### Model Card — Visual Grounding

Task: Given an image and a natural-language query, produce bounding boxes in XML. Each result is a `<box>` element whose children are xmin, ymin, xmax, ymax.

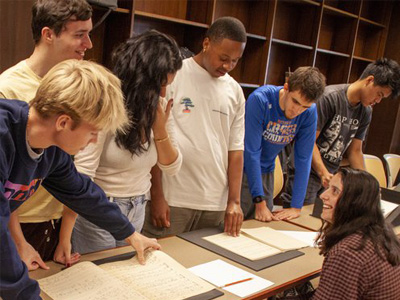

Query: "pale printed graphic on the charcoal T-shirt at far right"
<box><xmin>318</xmin><ymin>114</ymin><xmax>360</xmax><ymax>164</ymax></box>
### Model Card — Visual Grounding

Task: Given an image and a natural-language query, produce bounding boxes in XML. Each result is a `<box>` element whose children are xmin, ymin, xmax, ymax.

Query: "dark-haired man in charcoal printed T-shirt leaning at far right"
<box><xmin>282</xmin><ymin>58</ymin><xmax>400</xmax><ymax>210</ymax></box>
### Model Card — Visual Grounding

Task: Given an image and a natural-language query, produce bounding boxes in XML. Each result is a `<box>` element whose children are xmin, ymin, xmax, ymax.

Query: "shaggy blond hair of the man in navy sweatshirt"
<box><xmin>29</xmin><ymin>59</ymin><xmax>129</xmax><ymax>132</ymax></box>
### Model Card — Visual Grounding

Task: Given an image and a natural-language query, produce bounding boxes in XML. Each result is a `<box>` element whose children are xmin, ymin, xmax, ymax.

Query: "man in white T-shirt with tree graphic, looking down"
<box><xmin>143</xmin><ymin>17</ymin><xmax>246</xmax><ymax>237</ymax></box>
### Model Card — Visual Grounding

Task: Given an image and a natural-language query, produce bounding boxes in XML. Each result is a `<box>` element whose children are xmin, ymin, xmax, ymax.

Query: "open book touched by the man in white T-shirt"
<box><xmin>203</xmin><ymin>227</ymin><xmax>308</xmax><ymax>260</ymax></box>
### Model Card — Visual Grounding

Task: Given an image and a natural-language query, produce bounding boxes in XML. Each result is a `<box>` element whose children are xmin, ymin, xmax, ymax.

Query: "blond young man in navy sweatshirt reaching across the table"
<box><xmin>0</xmin><ymin>60</ymin><xmax>160</xmax><ymax>300</ymax></box>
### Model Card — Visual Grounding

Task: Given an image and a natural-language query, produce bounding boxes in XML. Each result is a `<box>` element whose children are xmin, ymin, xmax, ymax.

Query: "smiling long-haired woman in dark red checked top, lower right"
<box><xmin>312</xmin><ymin>168</ymin><xmax>400</xmax><ymax>300</ymax></box>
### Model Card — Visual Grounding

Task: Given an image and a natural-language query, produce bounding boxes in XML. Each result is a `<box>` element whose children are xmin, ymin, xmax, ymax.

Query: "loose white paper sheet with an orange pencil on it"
<box><xmin>188</xmin><ymin>259</ymin><xmax>274</xmax><ymax>297</ymax></box>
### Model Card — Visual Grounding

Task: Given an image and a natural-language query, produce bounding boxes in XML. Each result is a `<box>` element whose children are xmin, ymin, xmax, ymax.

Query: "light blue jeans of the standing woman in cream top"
<box><xmin>71</xmin><ymin>195</ymin><xmax>147</xmax><ymax>254</ymax></box>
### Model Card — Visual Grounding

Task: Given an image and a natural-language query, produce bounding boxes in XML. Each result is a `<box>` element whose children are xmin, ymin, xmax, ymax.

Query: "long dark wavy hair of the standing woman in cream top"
<box><xmin>112</xmin><ymin>30</ymin><xmax>182</xmax><ymax>155</ymax></box>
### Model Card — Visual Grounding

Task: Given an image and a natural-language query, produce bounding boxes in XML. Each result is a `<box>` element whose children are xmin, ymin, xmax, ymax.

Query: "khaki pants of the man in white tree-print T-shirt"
<box><xmin>142</xmin><ymin>201</ymin><xmax>225</xmax><ymax>238</ymax></box>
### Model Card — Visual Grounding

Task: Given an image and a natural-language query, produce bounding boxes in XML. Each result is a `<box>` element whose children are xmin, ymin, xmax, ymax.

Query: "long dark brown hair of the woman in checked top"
<box><xmin>317</xmin><ymin>168</ymin><xmax>400</xmax><ymax>266</ymax></box>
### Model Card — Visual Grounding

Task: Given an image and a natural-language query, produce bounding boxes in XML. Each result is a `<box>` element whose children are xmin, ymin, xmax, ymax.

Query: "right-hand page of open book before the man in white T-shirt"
<box><xmin>241</xmin><ymin>227</ymin><xmax>308</xmax><ymax>251</ymax></box>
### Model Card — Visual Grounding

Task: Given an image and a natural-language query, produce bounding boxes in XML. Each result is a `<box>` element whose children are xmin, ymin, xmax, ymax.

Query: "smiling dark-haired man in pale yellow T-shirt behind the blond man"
<box><xmin>0</xmin><ymin>0</ymin><xmax>92</xmax><ymax>270</ymax></box>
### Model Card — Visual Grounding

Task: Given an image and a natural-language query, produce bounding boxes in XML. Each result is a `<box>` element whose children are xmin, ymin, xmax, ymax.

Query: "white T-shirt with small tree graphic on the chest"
<box><xmin>163</xmin><ymin>58</ymin><xmax>245</xmax><ymax>211</ymax></box>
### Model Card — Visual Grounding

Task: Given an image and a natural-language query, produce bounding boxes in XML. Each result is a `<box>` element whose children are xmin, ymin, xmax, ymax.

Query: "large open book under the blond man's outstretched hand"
<box><xmin>39</xmin><ymin>251</ymin><xmax>214</xmax><ymax>300</ymax></box>
